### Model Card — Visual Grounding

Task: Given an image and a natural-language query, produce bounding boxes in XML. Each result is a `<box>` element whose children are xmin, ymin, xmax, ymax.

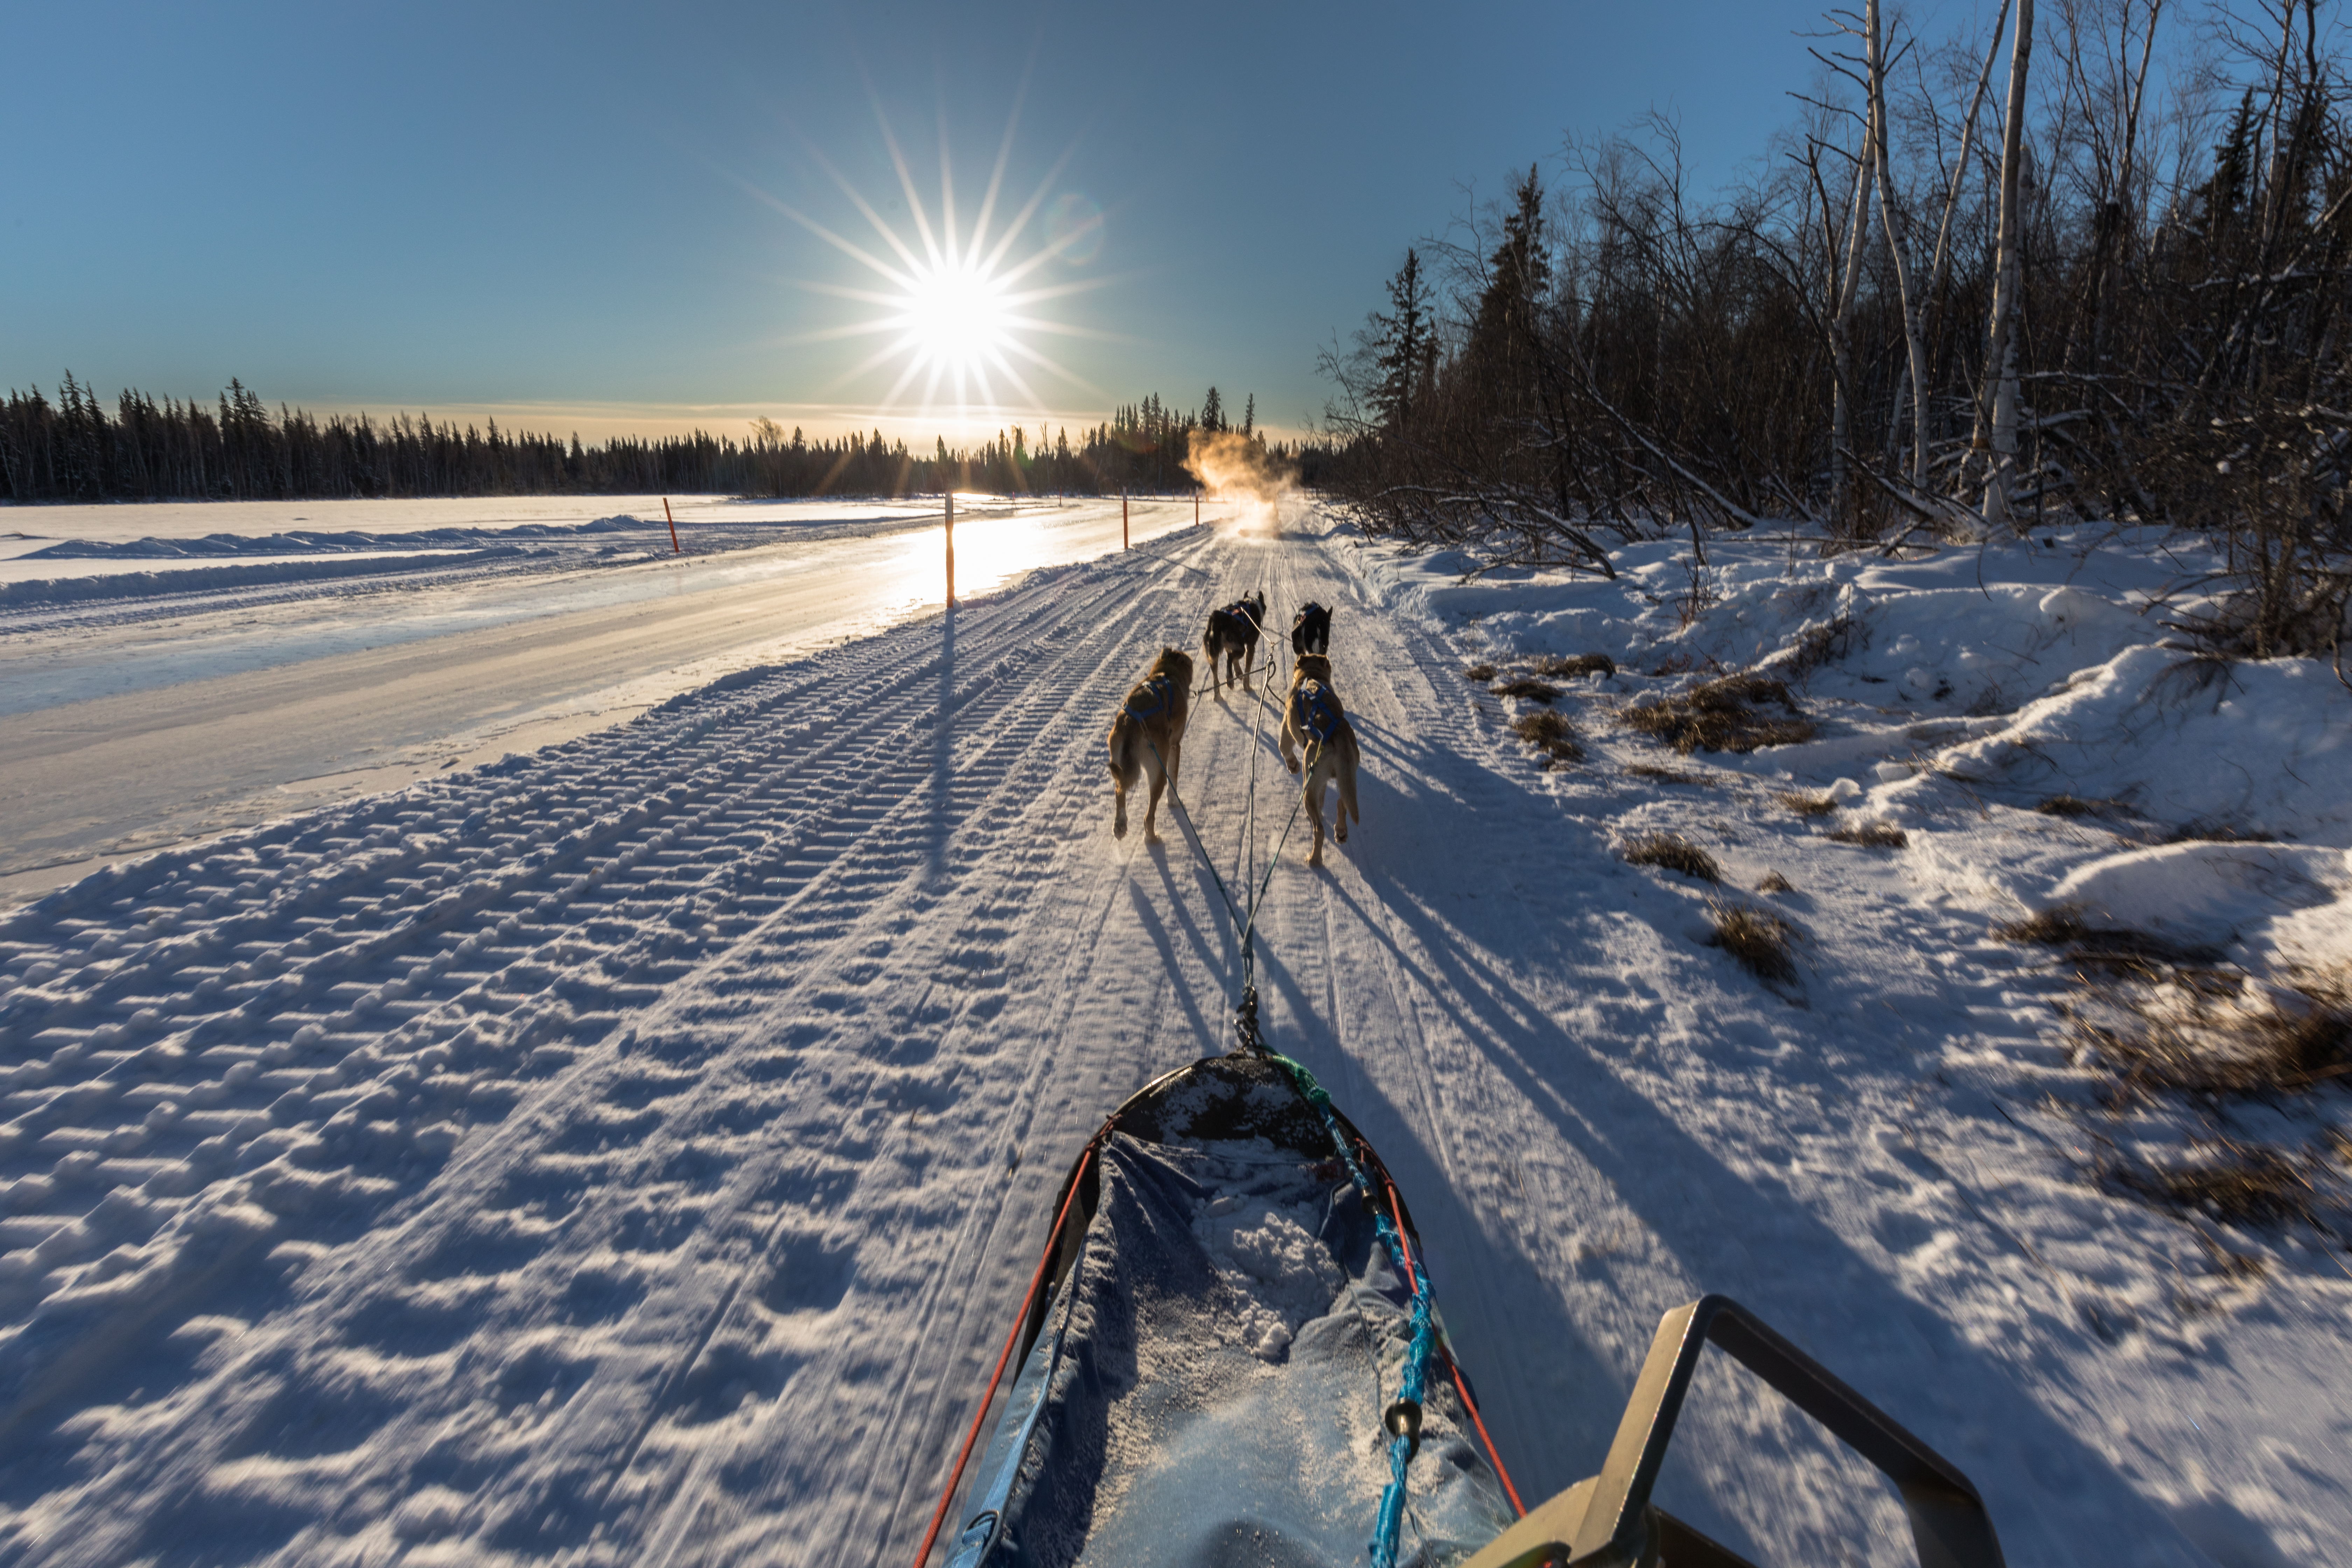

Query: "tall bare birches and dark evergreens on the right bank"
<box><xmin>1320</xmin><ymin>0</ymin><xmax>2352</xmax><ymax>656</ymax></box>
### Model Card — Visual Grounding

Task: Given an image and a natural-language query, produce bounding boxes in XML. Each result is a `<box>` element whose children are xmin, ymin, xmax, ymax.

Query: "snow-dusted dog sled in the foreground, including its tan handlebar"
<box><xmin>917</xmin><ymin>1053</ymin><xmax>2002</xmax><ymax>1568</ymax></box>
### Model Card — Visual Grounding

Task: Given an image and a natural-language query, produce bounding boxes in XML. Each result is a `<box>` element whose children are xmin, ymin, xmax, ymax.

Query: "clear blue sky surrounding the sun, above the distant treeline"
<box><xmin>0</xmin><ymin>0</ymin><xmax>1853</xmax><ymax>440</ymax></box>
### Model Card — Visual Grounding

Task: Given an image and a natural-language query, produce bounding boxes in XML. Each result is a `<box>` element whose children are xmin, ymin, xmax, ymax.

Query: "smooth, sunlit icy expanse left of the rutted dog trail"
<box><xmin>0</xmin><ymin>498</ymin><xmax>1221</xmax><ymax>903</ymax></box>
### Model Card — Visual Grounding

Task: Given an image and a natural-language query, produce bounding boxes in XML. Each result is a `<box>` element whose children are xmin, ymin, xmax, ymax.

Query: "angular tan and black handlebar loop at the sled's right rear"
<box><xmin>1463</xmin><ymin>1295</ymin><xmax>2002</xmax><ymax>1568</ymax></box>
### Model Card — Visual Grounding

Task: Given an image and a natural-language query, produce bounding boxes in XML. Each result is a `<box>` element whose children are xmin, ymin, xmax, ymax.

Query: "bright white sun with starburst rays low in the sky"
<box><xmin>752</xmin><ymin>104</ymin><xmax>1120</xmax><ymax>425</ymax></box>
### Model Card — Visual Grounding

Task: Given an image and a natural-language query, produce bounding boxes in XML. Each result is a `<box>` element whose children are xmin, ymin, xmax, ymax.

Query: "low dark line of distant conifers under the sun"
<box><xmin>0</xmin><ymin>374</ymin><xmax>1320</xmax><ymax>501</ymax></box>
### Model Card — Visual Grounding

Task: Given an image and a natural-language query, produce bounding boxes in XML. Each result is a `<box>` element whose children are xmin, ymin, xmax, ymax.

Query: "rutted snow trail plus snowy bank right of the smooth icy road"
<box><xmin>0</xmin><ymin>517</ymin><xmax>2352</xmax><ymax>1568</ymax></box>
